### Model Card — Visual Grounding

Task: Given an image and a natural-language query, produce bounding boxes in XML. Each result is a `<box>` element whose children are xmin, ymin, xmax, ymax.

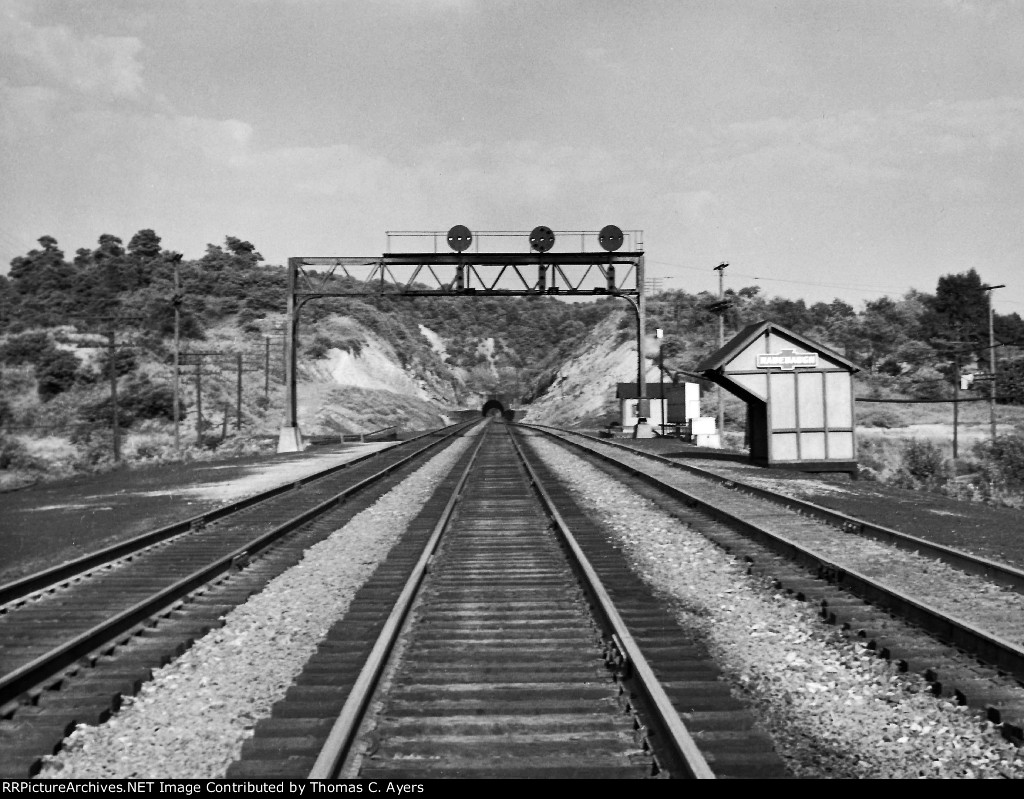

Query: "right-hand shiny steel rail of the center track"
<box><xmin>510</xmin><ymin>430</ymin><xmax>716</xmax><ymax>780</ymax></box>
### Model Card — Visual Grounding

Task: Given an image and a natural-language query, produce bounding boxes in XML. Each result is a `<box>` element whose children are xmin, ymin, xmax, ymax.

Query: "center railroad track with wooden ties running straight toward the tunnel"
<box><xmin>227</xmin><ymin>424</ymin><xmax>786</xmax><ymax>779</ymax></box>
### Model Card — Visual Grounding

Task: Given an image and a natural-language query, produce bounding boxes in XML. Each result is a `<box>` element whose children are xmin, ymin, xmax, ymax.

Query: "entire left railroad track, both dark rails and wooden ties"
<box><xmin>0</xmin><ymin>425</ymin><xmax>471</xmax><ymax>777</ymax></box>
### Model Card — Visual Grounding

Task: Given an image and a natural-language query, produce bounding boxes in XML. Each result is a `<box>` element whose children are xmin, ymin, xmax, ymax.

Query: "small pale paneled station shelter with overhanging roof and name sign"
<box><xmin>696</xmin><ymin>321</ymin><xmax>860</xmax><ymax>474</ymax></box>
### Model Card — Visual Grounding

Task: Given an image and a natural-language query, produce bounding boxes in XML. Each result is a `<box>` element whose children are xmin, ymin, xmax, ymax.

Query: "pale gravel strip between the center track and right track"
<box><xmin>530</xmin><ymin>437</ymin><xmax>1024</xmax><ymax>779</ymax></box>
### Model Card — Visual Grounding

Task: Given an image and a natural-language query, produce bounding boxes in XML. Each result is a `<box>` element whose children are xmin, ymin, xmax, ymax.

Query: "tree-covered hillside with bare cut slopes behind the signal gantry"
<box><xmin>0</xmin><ymin>229</ymin><xmax>1024</xmax><ymax>482</ymax></box>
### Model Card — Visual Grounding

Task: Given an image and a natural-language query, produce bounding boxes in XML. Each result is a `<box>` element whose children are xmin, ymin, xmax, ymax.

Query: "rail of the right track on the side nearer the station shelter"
<box><xmin>522</xmin><ymin>424</ymin><xmax>1024</xmax><ymax>593</ymax></box>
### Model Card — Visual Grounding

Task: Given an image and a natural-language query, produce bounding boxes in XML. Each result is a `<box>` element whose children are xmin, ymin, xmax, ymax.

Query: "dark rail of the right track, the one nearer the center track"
<box><xmin>527</xmin><ymin>426</ymin><xmax>1024</xmax><ymax>680</ymax></box>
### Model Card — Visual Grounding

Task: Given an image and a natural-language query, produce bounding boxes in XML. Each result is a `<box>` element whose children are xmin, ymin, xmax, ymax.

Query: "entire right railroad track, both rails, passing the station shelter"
<box><xmin>524</xmin><ymin>425</ymin><xmax>1024</xmax><ymax>741</ymax></box>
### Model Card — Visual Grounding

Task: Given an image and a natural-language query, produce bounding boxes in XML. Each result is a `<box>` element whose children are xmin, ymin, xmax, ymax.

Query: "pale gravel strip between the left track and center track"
<box><xmin>39</xmin><ymin>436</ymin><xmax>472</xmax><ymax>779</ymax></box>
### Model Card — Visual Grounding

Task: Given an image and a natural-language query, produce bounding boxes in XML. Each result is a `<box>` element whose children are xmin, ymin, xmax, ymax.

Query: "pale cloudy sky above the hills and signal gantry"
<box><xmin>0</xmin><ymin>0</ymin><xmax>1024</xmax><ymax>314</ymax></box>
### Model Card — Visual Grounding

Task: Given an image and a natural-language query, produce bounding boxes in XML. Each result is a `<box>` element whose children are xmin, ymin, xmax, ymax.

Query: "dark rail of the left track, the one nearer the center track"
<box><xmin>0</xmin><ymin>426</ymin><xmax>477</xmax><ymax>707</ymax></box>
